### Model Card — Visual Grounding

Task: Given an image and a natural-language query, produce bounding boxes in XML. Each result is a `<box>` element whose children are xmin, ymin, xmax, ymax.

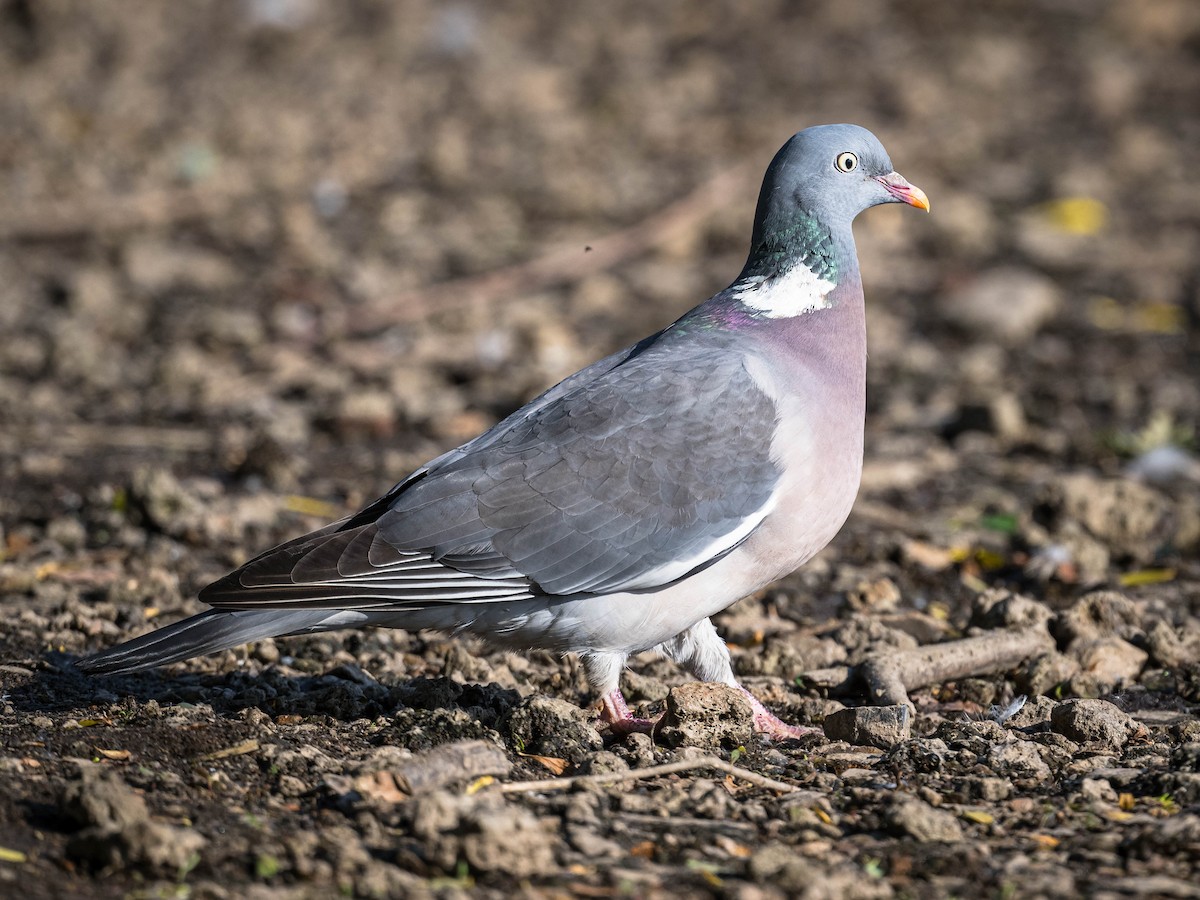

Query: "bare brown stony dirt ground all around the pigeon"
<box><xmin>0</xmin><ymin>0</ymin><xmax>1200</xmax><ymax>900</ymax></box>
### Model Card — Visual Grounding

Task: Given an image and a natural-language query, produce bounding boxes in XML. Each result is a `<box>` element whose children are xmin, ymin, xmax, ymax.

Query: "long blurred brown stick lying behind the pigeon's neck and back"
<box><xmin>350</xmin><ymin>164</ymin><xmax>750</xmax><ymax>336</ymax></box>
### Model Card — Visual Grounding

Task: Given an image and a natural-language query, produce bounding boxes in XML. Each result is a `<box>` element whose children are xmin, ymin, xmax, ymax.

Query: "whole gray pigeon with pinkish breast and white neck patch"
<box><xmin>77</xmin><ymin>125</ymin><xmax>929</xmax><ymax>739</ymax></box>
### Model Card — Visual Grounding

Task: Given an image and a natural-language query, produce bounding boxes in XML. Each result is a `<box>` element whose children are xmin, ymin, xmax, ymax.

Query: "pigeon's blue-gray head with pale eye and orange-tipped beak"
<box><xmin>750</xmin><ymin>125</ymin><xmax>929</xmax><ymax>267</ymax></box>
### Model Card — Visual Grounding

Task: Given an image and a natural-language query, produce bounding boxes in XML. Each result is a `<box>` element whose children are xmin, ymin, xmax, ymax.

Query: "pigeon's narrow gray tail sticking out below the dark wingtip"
<box><xmin>76</xmin><ymin>610</ymin><xmax>347</xmax><ymax>674</ymax></box>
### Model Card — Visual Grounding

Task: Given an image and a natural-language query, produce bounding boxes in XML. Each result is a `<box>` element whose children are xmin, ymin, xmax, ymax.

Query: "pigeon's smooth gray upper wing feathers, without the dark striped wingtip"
<box><xmin>378</xmin><ymin>352</ymin><xmax>779</xmax><ymax>594</ymax></box>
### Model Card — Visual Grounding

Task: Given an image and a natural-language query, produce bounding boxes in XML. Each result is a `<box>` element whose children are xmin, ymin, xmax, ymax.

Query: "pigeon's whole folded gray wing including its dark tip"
<box><xmin>200</xmin><ymin>344</ymin><xmax>779</xmax><ymax>608</ymax></box>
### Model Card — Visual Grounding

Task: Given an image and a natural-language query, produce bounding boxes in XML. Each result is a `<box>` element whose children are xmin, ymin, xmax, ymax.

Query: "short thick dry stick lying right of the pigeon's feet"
<box><xmin>800</xmin><ymin>625</ymin><xmax>1054</xmax><ymax>706</ymax></box>
